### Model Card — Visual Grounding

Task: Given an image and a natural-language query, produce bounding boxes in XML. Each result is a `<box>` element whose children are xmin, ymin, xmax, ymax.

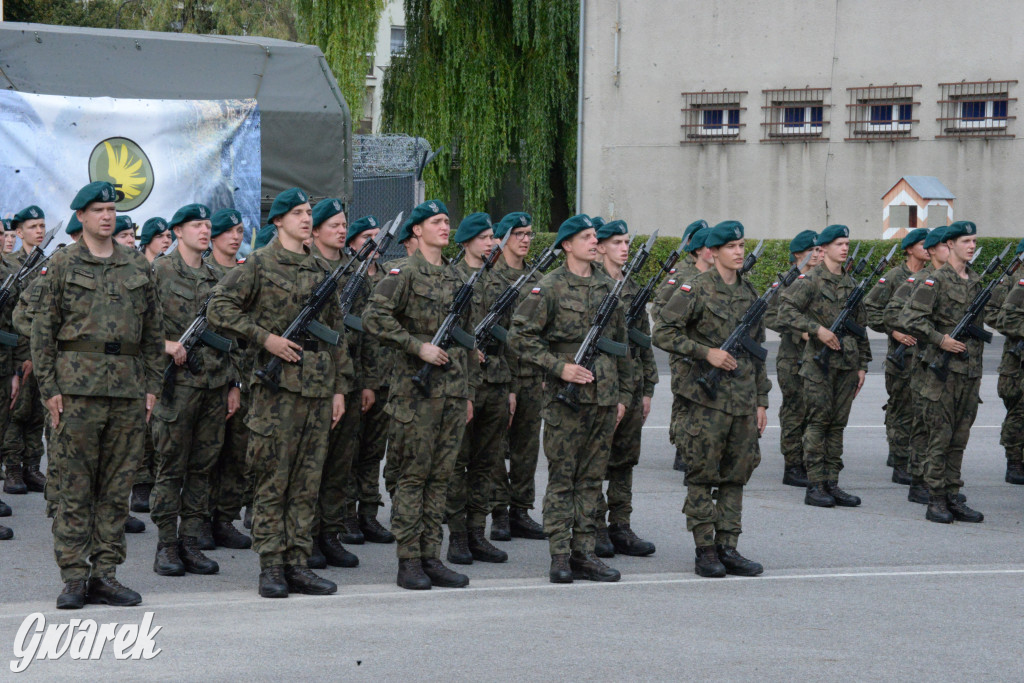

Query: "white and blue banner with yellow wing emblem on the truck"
<box><xmin>0</xmin><ymin>90</ymin><xmax>260</xmax><ymax>255</ymax></box>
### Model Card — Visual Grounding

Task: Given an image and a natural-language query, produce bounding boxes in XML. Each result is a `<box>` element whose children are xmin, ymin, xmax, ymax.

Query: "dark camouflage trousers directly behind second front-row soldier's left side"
<box><xmin>210</xmin><ymin>391</ymin><xmax>253</xmax><ymax>522</ymax></box>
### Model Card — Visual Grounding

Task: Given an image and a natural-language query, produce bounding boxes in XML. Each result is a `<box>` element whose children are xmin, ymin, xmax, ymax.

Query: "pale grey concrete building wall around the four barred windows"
<box><xmin>581</xmin><ymin>0</ymin><xmax>1024</xmax><ymax>238</ymax></box>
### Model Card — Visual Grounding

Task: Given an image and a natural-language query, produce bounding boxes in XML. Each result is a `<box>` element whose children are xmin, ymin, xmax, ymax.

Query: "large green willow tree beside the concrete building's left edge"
<box><xmin>383</xmin><ymin>0</ymin><xmax>579</xmax><ymax>225</ymax></box>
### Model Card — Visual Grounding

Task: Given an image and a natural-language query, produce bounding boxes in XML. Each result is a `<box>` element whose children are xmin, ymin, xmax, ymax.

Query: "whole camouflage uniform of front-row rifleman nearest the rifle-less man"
<box><xmin>207</xmin><ymin>241</ymin><xmax>357</xmax><ymax>569</ymax></box>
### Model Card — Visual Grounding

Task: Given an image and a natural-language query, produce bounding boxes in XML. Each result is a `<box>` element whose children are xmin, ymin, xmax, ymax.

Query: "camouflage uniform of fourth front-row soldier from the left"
<box><xmin>508</xmin><ymin>265</ymin><xmax>634</xmax><ymax>555</ymax></box>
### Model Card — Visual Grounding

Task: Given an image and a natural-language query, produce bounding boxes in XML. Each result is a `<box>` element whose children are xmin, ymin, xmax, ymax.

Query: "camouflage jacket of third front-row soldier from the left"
<box><xmin>362</xmin><ymin>252</ymin><xmax>480</xmax><ymax>400</ymax></box>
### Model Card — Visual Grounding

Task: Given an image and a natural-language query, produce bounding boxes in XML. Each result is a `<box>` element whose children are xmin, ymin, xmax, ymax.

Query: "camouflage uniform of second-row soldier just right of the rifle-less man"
<box><xmin>151</xmin><ymin>251</ymin><xmax>238</xmax><ymax>544</ymax></box>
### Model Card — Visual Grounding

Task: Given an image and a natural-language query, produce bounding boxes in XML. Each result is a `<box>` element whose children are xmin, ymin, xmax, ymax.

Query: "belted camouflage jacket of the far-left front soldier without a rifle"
<box><xmin>29</xmin><ymin>240</ymin><xmax>167</xmax><ymax>400</ymax></box>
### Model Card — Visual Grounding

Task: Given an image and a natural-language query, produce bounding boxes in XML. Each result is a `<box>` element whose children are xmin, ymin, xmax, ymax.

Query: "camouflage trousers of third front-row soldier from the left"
<box><xmin>388</xmin><ymin>396</ymin><xmax>467</xmax><ymax>560</ymax></box>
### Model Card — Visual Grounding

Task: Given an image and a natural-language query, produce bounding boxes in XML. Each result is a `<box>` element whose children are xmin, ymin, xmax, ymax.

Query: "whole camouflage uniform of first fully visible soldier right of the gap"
<box><xmin>778</xmin><ymin>263</ymin><xmax>871</xmax><ymax>485</ymax></box>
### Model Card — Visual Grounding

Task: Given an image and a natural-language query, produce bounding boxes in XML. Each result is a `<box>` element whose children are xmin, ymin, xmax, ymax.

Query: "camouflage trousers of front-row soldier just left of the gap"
<box><xmin>677</xmin><ymin>403</ymin><xmax>761</xmax><ymax>548</ymax></box>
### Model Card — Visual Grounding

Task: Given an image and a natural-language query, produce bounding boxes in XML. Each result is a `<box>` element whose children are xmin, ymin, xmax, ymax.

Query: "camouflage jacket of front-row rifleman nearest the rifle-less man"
<box><xmin>207</xmin><ymin>240</ymin><xmax>353</xmax><ymax>398</ymax></box>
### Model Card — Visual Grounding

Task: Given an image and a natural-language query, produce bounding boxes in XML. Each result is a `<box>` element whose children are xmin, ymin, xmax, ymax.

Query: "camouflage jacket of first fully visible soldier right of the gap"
<box><xmin>777</xmin><ymin>263</ymin><xmax>871</xmax><ymax>382</ymax></box>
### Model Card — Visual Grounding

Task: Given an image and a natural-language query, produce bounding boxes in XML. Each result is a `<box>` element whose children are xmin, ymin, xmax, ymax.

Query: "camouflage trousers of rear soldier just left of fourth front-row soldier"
<box><xmin>490</xmin><ymin>375</ymin><xmax>544</xmax><ymax>510</ymax></box>
